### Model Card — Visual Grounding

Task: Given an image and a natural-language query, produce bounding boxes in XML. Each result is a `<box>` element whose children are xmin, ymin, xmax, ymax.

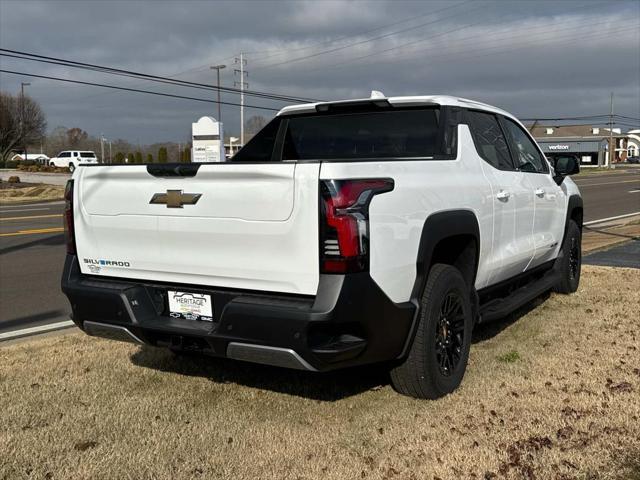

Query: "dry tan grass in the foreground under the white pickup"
<box><xmin>0</xmin><ymin>267</ymin><xmax>640</xmax><ymax>480</ymax></box>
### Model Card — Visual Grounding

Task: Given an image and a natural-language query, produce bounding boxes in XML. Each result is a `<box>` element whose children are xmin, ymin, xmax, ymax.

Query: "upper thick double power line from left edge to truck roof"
<box><xmin>0</xmin><ymin>48</ymin><xmax>318</xmax><ymax>103</ymax></box>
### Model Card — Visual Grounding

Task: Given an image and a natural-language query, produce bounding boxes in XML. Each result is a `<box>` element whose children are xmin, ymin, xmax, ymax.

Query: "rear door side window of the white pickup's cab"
<box><xmin>465</xmin><ymin>110</ymin><xmax>514</xmax><ymax>170</ymax></box>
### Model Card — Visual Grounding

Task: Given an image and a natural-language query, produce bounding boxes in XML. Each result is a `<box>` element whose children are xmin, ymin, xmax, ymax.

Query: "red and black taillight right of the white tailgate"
<box><xmin>320</xmin><ymin>178</ymin><xmax>393</xmax><ymax>273</ymax></box>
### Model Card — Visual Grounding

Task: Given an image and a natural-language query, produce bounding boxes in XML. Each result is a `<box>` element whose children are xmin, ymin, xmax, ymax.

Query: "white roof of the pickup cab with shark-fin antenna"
<box><xmin>278</xmin><ymin>92</ymin><xmax>515</xmax><ymax>118</ymax></box>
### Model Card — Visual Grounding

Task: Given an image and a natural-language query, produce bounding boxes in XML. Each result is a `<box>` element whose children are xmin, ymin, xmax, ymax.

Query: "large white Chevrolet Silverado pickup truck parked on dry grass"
<box><xmin>62</xmin><ymin>96</ymin><xmax>583</xmax><ymax>398</ymax></box>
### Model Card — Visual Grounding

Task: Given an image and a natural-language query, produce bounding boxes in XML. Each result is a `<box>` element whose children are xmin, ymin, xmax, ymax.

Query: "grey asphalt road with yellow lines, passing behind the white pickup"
<box><xmin>0</xmin><ymin>169</ymin><xmax>640</xmax><ymax>333</ymax></box>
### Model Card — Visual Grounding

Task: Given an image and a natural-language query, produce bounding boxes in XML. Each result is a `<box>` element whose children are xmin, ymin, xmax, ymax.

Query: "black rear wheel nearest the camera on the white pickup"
<box><xmin>391</xmin><ymin>263</ymin><xmax>473</xmax><ymax>399</ymax></box>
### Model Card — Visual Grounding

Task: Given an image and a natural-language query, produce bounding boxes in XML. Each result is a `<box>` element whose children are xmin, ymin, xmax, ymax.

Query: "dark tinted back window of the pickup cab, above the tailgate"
<box><xmin>282</xmin><ymin>108</ymin><xmax>448</xmax><ymax>160</ymax></box>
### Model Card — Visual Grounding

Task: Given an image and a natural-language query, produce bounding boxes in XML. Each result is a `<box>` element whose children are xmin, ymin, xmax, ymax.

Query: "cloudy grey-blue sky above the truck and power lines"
<box><xmin>0</xmin><ymin>0</ymin><xmax>640</xmax><ymax>143</ymax></box>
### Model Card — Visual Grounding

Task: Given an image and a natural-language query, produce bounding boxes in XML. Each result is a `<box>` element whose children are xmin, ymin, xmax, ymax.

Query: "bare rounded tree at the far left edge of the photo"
<box><xmin>0</xmin><ymin>92</ymin><xmax>47</xmax><ymax>160</ymax></box>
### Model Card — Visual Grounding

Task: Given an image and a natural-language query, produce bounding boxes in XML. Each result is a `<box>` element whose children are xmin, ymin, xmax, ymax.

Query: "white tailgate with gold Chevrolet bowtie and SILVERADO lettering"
<box><xmin>74</xmin><ymin>163</ymin><xmax>320</xmax><ymax>295</ymax></box>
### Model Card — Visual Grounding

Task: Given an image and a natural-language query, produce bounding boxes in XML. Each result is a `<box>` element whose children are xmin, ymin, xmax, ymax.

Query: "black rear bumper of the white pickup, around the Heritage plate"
<box><xmin>62</xmin><ymin>255</ymin><xmax>416</xmax><ymax>371</ymax></box>
